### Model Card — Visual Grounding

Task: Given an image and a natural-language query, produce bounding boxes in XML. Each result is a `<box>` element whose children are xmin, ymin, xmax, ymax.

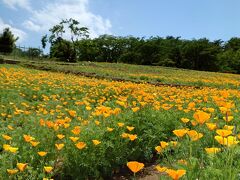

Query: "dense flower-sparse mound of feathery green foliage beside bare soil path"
<box><xmin>63</xmin><ymin>107</ymin><xmax>179</xmax><ymax>179</ymax></box>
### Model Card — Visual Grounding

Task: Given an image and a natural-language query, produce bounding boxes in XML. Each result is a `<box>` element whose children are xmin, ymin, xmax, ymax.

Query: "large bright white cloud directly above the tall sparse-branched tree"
<box><xmin>23</xmin><ymin>0</ymin><xmax>111</xmax><ymax>37</ymax></box>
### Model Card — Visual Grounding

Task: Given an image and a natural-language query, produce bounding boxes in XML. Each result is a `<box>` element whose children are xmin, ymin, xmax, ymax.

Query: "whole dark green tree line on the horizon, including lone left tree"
<box><xmin>0</xmin><ymin>18</ymin><xmax>240</xmax><ymax>73</ymax></box>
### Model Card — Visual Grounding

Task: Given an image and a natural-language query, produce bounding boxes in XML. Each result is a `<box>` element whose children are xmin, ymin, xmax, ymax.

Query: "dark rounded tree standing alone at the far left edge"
<box><xmin>0</xmin><ymin>28</ymin><xmax>18</xmax><ymax>53</ymax></box>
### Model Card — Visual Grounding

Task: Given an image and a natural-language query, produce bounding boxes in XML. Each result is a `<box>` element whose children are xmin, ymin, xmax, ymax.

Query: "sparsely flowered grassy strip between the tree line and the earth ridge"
<box><xmin>1</xmin><ymin>54</ymin><xmax>240</xmax><ymax>88</ymax></box>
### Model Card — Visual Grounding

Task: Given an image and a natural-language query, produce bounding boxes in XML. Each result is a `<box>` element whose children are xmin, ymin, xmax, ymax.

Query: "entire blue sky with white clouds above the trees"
<box><xmin>0</xmin><ymin>0</ymin><xmax>240</xmax><ymax>47</ymax></box>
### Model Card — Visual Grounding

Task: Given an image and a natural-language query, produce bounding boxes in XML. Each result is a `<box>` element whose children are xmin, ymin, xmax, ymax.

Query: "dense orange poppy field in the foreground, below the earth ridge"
<box><xmin>0</xmin><ymin>65</ymin><xmax>240</xmax><ymax>180</ymax></box>
